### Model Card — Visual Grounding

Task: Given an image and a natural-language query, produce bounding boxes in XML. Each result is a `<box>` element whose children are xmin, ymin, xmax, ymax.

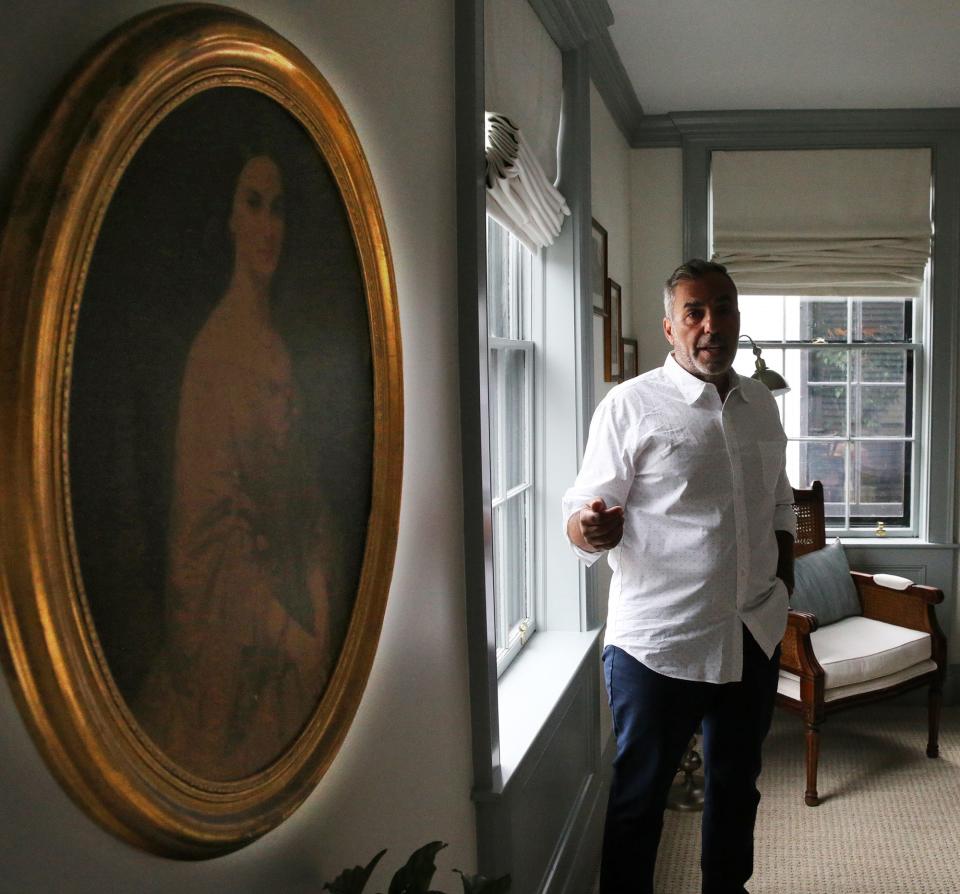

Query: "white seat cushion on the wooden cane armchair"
<box><xmin>779</xmin><ymin>616</ymin><xmax>936</xmax><ymax>701</ymax></box>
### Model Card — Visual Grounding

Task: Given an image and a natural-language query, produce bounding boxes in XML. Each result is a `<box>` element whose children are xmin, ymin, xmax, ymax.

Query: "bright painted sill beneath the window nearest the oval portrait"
<box><xmin>497</xmin><ymin>630</ymin><xmax>600</xmax><ymax>787</ymax></box>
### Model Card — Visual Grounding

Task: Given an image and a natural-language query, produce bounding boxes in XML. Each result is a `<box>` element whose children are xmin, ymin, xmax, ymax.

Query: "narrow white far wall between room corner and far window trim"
<box><xmin>630</xmin><ymin>149</ymin><xmax>685</xmax><ymax>372</ymax></box>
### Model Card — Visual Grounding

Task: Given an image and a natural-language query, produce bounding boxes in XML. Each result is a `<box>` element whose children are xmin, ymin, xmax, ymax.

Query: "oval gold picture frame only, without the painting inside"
<box><xmin>0</xmin><ymin>4</ymin><xmax>403</xmax><ymax>858</ymax></box>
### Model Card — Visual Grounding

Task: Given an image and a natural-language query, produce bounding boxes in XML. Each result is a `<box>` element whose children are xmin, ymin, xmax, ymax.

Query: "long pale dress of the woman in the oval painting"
<box><xmin>137</xmin><ymin>300</ymin><xmax>333</xmax><ymax>779</ymax></box>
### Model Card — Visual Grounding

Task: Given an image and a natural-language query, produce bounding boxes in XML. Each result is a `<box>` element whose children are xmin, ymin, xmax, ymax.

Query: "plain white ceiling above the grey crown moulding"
<box><xmin>608</xmin><ymin>0</ymin><xmax>960</xmax><ymax>115</ymax></box>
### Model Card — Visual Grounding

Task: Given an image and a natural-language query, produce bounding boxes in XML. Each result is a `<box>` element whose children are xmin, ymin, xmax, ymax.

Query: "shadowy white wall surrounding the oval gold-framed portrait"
<box><xmin>0</xmin><ymin>0</ymin><xmax>476</xmax><ymax>894</ymax></box>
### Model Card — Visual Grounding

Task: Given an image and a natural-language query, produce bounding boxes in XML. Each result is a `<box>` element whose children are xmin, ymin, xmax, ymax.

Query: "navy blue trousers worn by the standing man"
<box><xmin>600</xmin><ymin>627</ymin><xmax>780</xmax><ymax>894</ymax></box>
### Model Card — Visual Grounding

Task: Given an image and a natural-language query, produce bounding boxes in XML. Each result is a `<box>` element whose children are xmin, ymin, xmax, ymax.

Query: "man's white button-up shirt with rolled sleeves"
<box><xmin>563</xmin><ymin>355</ymin><xmax>796</xmax><ymax>683</ymax></box>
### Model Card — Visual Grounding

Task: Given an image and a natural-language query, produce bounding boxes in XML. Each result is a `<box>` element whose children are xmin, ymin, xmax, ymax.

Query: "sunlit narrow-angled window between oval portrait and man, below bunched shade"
<box><xmin>487</xmin><ymin>217</ymin><xmax>542</xmax><ymax>671</ymax></box>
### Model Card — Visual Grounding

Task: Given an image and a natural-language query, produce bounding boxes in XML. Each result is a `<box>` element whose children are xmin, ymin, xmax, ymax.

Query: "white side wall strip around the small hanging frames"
<box><xmin>590</xmin><ymin>83</ymin><xmax>635</xmax><ymax>403</ymax></box>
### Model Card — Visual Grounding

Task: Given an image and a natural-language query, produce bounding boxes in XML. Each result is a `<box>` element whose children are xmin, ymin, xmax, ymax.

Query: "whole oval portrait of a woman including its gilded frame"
<box><xmin>0</xmin><ymin>4</ymin><xmax>403</xmax><ymax>859</ymax></box>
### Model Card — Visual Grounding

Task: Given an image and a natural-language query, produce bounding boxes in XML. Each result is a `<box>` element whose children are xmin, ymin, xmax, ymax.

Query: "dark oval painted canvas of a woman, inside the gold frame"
<box><xmin>72</xmin><ymin>91</ymin><xmax>372</xmax><ymax>780</ymax></box>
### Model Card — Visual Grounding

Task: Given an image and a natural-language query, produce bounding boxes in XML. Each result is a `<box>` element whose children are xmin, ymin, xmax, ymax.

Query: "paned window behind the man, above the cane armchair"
<box><xmin>735</xmin><ymin>295</ymin><xmax>922</xmax><ymax>536</ymax></box>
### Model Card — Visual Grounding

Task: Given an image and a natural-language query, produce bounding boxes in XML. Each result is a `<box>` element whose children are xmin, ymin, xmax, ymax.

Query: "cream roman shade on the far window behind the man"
<box><xmin>710</xmin><ymin>149</ymin><xmax>932</xmax><ymax>297</ymax></box>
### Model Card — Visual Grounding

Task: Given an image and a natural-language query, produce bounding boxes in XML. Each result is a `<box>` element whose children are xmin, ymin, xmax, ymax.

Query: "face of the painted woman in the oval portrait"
<box><xmin>229</xmin><ymin>155</ymin><xmax>284</xmax><ymax>279</ymax></box>
